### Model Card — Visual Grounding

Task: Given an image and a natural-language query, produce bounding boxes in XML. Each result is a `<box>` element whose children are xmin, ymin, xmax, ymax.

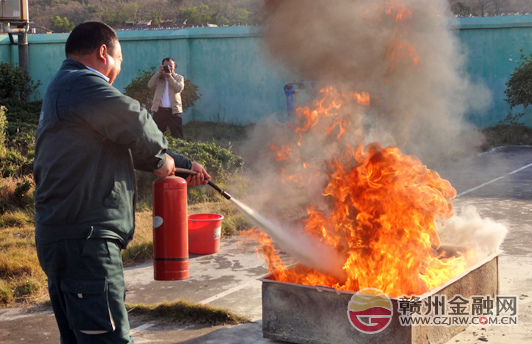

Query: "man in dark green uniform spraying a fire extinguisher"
<box><xmin>34</xmin><ymin>22</ymin><xmax>209</xmax><ymax>344</ymax></box>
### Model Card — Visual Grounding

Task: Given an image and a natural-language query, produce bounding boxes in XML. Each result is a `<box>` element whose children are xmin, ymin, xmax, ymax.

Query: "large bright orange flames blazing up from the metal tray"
<box><xmin>241</xmin><ymin>87</ymin><xmax>466</xmax><ymax>297</ymax></box>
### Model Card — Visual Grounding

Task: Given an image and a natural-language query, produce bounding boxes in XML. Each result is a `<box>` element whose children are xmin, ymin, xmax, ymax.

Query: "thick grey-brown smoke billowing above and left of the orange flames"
<box><xmin>243</xmin><ymin>0</ymin><xmax>490</xmax><ymax>216</ymax></box>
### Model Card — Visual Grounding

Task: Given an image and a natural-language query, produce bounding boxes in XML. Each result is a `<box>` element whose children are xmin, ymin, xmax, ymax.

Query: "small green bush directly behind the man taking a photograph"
<box><xmin>124</xmin><ymin>67</ymin><xmax>201</xmax><ymax>112</ymax></box>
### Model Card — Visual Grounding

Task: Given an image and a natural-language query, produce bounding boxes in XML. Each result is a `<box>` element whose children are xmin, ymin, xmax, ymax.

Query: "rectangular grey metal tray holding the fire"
<box><xmin>260</xmin><ymin>252</ymin><xmax>500</xmax><ymax>344</ymax></box>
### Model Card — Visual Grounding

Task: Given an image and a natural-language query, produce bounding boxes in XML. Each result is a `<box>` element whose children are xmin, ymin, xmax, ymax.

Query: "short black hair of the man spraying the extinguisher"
<box><xmin>65</xmin><ymin>22</ymin><xmax>118</xmax><ymax>58</ymax></box>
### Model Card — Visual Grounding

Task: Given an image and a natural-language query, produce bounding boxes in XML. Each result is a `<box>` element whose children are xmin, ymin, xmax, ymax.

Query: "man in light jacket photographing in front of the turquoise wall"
<box><xmin>148</xmin><ymin>57</ymin><xmax>185</xmax><ymax>139</ymax></box>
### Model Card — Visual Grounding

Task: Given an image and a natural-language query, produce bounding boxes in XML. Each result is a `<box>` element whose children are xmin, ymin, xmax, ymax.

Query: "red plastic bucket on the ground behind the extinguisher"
<box><xmin>188</xmin><ymin>214</ymin><xmax>224</xmax><ymax>254</ymax></box>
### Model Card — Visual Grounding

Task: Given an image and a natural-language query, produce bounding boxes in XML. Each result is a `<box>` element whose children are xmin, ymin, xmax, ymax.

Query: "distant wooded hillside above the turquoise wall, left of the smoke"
<box><xmin>29</xmin><ymin>0</ymin><xmax>262</xmax><ymax>32</ymax></box>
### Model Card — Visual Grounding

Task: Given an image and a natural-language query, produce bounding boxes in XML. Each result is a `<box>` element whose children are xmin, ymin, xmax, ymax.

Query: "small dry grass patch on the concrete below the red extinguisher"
<box><xmin>126</xmin><ymin>300</ymin><xmax>251</xmax><ymax>326</ymax></box>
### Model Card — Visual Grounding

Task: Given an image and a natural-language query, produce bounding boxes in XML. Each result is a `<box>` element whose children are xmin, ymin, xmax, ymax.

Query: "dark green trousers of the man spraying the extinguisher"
<box><xmin>36</xmin><ymin>238</ymin><xmax>133</xmax><ymax>344</ymax></box>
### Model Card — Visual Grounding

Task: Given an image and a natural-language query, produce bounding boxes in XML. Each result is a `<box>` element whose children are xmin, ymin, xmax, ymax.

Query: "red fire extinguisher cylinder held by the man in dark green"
<box><xmin>153</xmin><ymin>176</ymin><xmax>188</xmax><ymax>281</ymax></box>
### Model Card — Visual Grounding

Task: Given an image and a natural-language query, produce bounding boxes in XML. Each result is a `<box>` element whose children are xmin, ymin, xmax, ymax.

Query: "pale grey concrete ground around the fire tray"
<box><xmin>0</xmin><ymin>147</ymin><xmax>532</xmax><ymax>344</ymax></box>
